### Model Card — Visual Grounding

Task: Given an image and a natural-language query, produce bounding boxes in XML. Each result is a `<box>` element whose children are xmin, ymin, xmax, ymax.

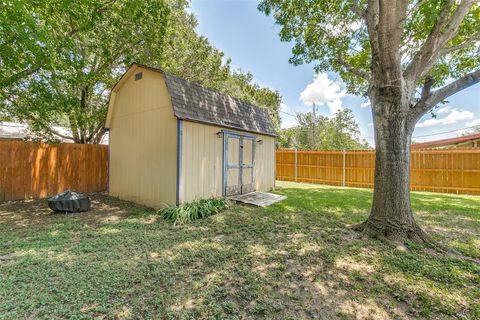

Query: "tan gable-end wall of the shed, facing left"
<box><xmin>109</xmin><ymin>68</ymin><xmax>177</xmax><ymax>207</ymax></box>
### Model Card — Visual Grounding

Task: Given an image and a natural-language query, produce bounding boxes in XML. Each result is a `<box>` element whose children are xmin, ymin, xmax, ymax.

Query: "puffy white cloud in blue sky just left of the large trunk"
<box><xmin>300</xmin><ymin>73</ymin><xmax>347</xmax><ymax>114</ymax></box>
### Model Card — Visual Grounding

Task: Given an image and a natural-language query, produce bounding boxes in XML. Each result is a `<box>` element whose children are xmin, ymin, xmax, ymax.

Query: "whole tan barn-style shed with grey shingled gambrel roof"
<box><xmin>105</xmin><ymin>63</ymin><xmax>276</xmax><ymax>207</ymax></box>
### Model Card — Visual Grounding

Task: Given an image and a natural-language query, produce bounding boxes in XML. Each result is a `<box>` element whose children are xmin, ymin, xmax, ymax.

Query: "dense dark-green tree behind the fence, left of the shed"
<box><xmin>0</xmin><ymin>0</ymin><xmax>170</xmax><ymax>143</ymax></box>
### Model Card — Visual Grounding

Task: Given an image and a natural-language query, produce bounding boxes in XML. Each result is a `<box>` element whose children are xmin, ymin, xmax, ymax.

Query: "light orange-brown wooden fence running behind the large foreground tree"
<box><xmin>276</xmin><ymin>148</ymin><xmax>480</xmax><ymax>194</ymax></box>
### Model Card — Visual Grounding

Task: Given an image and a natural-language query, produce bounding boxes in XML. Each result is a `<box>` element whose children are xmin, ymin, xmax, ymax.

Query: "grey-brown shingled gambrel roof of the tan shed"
<box><xmin>106</xmin><ymin>63</ymin><xmax>276</xmax><ymax>136</ymax></box>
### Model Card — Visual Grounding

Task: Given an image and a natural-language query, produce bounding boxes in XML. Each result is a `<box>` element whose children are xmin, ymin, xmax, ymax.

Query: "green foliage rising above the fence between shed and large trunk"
<box><xmin>278</xmin><ymin>109</ymin><xmax>369</xmax><ymax>150</ymax></box>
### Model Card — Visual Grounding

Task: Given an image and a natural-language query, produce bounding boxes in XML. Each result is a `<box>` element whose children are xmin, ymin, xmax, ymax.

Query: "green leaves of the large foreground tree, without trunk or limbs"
<box><xmin>258</xmin><ymin>0</ymin><xmax>480</xmax><ymax>95</ymax></box>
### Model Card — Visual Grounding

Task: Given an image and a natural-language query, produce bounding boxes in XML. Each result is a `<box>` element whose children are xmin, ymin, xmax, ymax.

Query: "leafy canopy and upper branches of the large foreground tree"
<box><xmin>259</xmin><ymin>0</ymin><xmax>480</xmax><ymax>100</ymax></box>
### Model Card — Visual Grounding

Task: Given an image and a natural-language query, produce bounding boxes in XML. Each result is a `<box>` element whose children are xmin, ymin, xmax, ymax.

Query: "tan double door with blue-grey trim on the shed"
<box><xmin>224</xmin><ymin>133</ymin><xmax>255</xmax><ymax>196</ymax></box>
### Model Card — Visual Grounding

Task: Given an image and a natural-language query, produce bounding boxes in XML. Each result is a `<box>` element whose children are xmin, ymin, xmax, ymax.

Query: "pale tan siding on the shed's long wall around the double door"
<box><xmin>180</xmin><ymin>121</ymin><xmax>275</xmax><ymax>202</ymax></box>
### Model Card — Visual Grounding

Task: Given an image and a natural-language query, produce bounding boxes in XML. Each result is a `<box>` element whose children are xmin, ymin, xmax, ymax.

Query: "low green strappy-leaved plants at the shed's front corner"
<box><xmin>159</xmin><ymin>198</ymin><xmax>229</xmax><ymax>225</ymax></box>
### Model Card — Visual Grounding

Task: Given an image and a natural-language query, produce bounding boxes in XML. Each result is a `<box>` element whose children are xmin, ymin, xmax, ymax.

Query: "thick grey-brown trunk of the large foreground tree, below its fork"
<box><xmin>355</xmin><ymin>97</ymin><xmax>428</xmax><ymax>243</ymax></box>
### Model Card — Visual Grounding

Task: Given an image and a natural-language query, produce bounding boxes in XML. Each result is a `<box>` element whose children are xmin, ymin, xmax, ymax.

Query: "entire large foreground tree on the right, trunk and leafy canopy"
<box><xmin>259</xmin><ymin>0</ymin><xmax>480</xmax><ymax>243</ymax></box>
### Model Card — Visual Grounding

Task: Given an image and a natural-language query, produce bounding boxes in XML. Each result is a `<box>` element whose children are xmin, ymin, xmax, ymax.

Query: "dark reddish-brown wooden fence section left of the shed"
<box><xmin>0</xmin><ymin>140</ymin><xmax>108</xmax><ymax>201</ymax></box>
